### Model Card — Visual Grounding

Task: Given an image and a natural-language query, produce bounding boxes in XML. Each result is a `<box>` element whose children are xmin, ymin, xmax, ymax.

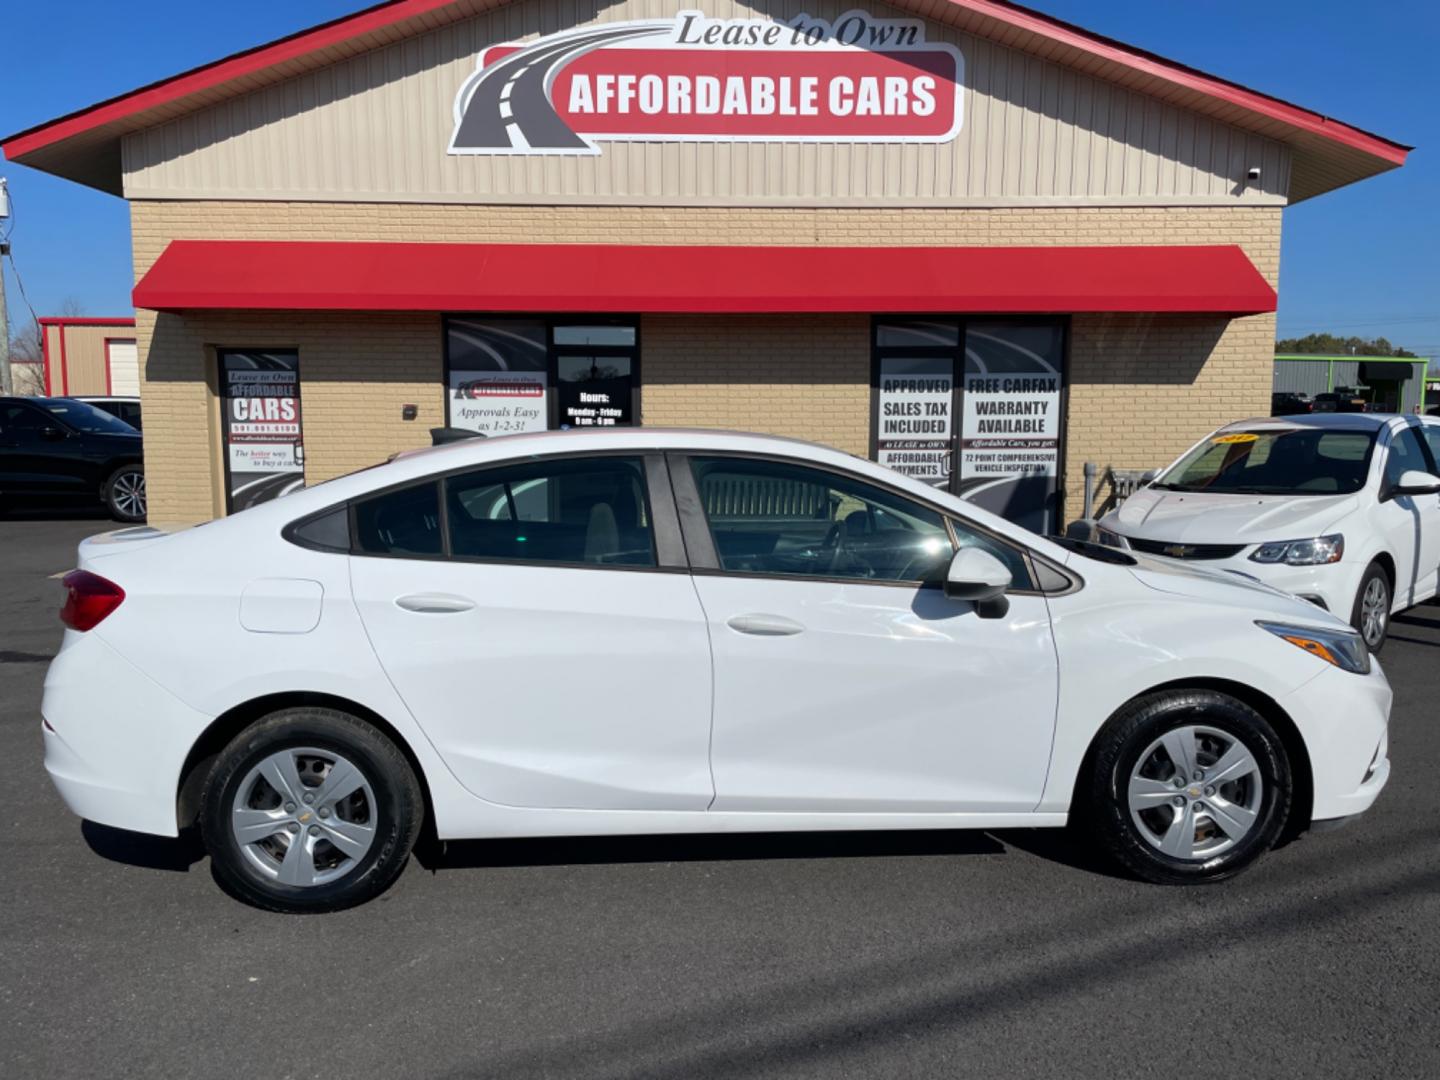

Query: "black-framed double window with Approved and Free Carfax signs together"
<box><xmin>874</xmin><ymin>317</ymin><xmax>1066</xmax><ymax>533</ymax></box>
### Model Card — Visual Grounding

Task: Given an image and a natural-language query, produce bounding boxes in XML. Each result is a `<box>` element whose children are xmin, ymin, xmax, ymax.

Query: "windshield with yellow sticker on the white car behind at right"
<box><xmin>1151</xmin><ymin>428</ymin><xmax>1375</xmax><ymax>495</ymax></box>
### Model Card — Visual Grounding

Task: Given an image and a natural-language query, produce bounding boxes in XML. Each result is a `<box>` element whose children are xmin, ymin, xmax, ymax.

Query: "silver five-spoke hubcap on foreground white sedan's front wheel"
<box><xmin>1129</xmin><ymin>724</ymin><xmax>1263</xmax><ymax>860</ymax></box>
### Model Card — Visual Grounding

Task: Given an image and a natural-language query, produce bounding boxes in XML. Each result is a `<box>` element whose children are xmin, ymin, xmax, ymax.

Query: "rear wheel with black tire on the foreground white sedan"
<box><xmin>200</xmin><ymin>708</ymin><xmax>423</xmax><ymax>912</ymax></box>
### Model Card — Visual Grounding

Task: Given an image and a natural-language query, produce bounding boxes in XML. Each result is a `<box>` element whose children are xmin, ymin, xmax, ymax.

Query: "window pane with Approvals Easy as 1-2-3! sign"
<box><xmin>446</xmin><ymin>318</ymin><xmax>549</xmax><ymax>435</ymax></box>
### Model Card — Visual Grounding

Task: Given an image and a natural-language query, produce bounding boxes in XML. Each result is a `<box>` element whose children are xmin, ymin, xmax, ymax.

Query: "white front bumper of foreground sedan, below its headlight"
<box><xmin>1280</xmin><ymin>660</ymin><xmax>1391</xmax><ymax>821</ymax></box>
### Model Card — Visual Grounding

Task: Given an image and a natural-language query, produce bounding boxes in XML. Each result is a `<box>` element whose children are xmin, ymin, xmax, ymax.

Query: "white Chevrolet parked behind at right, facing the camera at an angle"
<box><xmin>1100</xmin><ymin>413</ymin><xmax>1440</xmax><ymax>651</ymax></box>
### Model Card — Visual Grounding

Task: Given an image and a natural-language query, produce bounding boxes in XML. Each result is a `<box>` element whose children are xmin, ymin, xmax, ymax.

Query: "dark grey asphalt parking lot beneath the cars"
<box><xmin>0</xmin><ymin>518</ymin><xmax>1440</xmax><ymax>1080</ymax></box>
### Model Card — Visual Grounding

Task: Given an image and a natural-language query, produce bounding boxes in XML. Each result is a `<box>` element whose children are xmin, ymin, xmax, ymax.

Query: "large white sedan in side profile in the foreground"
<box><xmin>43</xmin><ymin>429</ymin><xmax>1390</xmax><ymax>912</ymax></box>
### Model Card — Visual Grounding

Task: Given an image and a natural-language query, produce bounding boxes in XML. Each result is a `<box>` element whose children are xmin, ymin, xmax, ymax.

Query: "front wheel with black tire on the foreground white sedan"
<box><xmin>1076</xmin><ymin>690</ymin><xmax>1292</xmax><ymax>884</ymax></box>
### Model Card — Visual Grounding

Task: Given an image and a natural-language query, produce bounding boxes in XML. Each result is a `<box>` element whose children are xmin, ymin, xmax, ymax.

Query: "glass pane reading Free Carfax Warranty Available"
<box><xmin>959</xmin><ymin>323</ymin><xmax>1064</xmax><ymax>531</ymax></box>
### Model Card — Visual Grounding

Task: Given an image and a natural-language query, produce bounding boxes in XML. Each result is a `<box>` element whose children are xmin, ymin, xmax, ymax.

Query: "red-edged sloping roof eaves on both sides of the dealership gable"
<box><xmin>0</xmin><ymin>0</ymin><xmax>1410</xmax><ymax>199</ymax></box>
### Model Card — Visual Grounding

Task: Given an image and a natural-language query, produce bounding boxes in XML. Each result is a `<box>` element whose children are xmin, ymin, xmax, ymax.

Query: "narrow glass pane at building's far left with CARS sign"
<box><xmin>220</xmin><ymin>350</ymin><xmax>305</xmax><ymax>513</ymax></box>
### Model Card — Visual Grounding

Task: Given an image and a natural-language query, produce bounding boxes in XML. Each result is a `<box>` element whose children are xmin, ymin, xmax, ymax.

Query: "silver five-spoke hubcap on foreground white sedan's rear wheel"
<box><xmin>230</xmin><ymin>746</ymin><xmax>376</xmax><ymax>888</ymax></box>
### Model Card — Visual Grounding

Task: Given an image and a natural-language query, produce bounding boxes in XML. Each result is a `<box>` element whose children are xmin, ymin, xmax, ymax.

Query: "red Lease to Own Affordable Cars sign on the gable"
<box><xmin>449</xmin><ymin>12</ymin><xmax>963</xmax><ymax>154</ymax></box>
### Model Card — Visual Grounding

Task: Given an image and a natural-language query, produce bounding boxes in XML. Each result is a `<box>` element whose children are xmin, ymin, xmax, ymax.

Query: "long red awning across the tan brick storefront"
<box><xmin>134</xmin><ymin>240</ymin><xmax>1276</xmax><ymax>315</ymax></box>
